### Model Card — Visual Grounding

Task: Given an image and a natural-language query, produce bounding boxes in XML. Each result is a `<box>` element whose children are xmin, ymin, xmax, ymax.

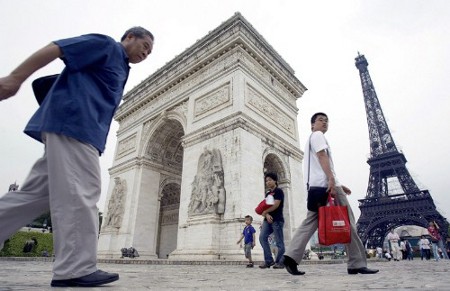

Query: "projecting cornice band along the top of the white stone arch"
<box><xmin>116</xmin><ymin>13</ymin><xmax>306</xmax><ymax>122</ymax></box>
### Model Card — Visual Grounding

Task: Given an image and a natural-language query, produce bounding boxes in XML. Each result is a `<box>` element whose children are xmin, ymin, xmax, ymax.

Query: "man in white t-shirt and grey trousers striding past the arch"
<box><xmin>284</xmin><ymin>112</ymin><xmax>378</xmax><ymax>275</ymax></box>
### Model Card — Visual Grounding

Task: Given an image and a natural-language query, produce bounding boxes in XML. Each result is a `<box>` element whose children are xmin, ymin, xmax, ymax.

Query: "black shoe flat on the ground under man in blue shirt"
<box><xmin>50</xmin><ymin>270</ymin><xmax>119</xmax><ymax>287</ymax></box>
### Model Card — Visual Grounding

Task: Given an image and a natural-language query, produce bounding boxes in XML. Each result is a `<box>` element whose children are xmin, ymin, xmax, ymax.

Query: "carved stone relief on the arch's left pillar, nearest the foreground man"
<box><xmin>104</xmin><ymin>177</ymin><xmax>127</xmax><ymax>228</ymax></box>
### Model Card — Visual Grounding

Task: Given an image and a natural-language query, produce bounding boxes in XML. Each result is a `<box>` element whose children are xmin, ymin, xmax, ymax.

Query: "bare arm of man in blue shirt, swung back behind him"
<box><xmin>0</xmin><ymin>43</ymin><xmax>62</xmax><ymax>101</ymax></box>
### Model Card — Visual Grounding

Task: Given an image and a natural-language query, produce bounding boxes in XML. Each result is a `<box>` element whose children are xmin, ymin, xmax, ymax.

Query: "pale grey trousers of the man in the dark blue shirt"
<box><xmin>0</xmin><ymin>133</ymin><xmax>101</xmax><ymax>280</ymax></box>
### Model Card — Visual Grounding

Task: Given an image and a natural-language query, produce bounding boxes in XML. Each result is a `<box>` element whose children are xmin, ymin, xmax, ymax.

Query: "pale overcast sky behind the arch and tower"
<box><xmin>0</xmin><ymin>0</ymin><xmax>450</xmax><ymax>224</ymax></box>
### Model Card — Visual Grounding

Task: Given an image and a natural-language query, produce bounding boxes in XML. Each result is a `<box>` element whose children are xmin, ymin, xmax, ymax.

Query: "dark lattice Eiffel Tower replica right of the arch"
<box><xmin>355</xmin><ymin>53</ymin><xmax>449</xmax><ymax>248</ymax></box>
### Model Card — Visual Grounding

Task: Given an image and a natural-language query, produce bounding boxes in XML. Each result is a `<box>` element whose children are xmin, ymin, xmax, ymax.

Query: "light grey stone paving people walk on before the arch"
<box><xmin>0</xmin><ymin>258</ymin><xmax>450</xmax><ymax>291</ymax></box>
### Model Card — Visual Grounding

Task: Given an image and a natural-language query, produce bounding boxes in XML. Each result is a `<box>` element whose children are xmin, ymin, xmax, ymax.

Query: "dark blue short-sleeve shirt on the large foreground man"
<box><xmin>24</xmin><ymin>34</ymin><xmax>130</xmax><ymax>153</ymax></box>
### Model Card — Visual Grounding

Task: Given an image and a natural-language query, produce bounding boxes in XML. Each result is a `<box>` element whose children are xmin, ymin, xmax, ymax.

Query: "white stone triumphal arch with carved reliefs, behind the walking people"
<box><xmin>98</xmin><ymin>13</ymin><xmax>306</xmax><ymax>260</ymax></box>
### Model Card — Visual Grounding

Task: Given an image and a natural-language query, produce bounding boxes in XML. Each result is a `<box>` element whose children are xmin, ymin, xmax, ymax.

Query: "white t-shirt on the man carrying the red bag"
<box><xmin>303</xmin><ymin>131</ymin><xmax>341</xmax><ymax>187</ymax></box>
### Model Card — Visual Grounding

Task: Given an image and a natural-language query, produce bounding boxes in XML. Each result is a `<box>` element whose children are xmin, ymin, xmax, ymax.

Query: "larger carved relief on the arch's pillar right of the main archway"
<box><xmin>189</xmin><ymin>148</ymin><xmax>225</xmax><ymax>216</ymax></box>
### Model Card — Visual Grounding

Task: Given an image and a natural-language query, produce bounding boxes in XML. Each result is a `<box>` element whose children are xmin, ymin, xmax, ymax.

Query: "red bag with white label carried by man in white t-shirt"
<box><xmin>319</xmin><ymin>196</ymin><xmax>351</xmax><ymax>246</ymax></box>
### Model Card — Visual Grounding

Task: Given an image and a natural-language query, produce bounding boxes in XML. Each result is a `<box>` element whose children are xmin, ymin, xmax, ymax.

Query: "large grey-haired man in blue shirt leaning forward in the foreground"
<box><xmin>0</xmin><ymin>27</ymin><xmax>154</xmax><ymax>287</ymax></box>
